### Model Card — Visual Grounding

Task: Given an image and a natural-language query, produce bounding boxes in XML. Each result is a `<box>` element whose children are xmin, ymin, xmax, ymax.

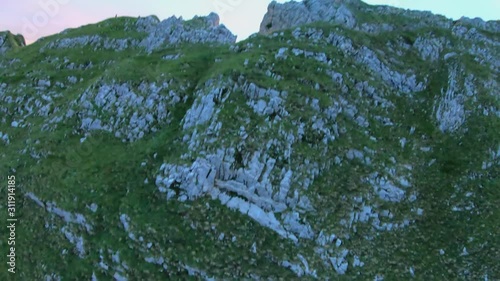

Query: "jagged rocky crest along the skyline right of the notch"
<box><xmin>260</xmin><ymin>0</ymin><xmax>500</xmax><ymax>34</ymax></box>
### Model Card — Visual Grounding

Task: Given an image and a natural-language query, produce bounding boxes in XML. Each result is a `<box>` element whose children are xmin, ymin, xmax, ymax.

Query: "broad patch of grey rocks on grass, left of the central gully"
<box><xmin>72</xmin><ymin>82</ymin><xmax>182</xmax><ymax>141</ymax></box>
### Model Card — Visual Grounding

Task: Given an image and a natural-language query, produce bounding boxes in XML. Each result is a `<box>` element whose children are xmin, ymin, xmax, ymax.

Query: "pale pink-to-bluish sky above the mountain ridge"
<box><xmin>0</xmin><ymin>0</ymin><xmax>500</xmax><ymax>44</ymax></box>
